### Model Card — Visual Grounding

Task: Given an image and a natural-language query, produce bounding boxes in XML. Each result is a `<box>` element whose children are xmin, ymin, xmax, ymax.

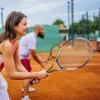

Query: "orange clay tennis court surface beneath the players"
<box><xmin>3</xmin><ymin>42</ymin><xmax>100</xmax><ymax>100</ymax></box>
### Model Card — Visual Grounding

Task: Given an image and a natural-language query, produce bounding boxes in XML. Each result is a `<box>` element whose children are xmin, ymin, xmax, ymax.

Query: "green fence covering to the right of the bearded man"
<box><xmin>37</xmin><ymin>25</ymin><xmax>61</xmax><ymax>52</ymax></box>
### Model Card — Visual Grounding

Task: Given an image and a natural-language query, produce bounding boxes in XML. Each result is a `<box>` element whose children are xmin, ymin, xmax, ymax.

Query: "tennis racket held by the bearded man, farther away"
<box><xmin>47</xmin><ymin>44</ymin><xmax>60</xmax><ymax>61</ymax></box>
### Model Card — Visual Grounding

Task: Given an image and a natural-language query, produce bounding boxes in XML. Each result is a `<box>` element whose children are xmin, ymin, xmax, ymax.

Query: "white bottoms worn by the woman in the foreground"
<box><xmin>0</xmin><ymin>73</ymin><xmax>10</xmax><ymax>100</ymax></box>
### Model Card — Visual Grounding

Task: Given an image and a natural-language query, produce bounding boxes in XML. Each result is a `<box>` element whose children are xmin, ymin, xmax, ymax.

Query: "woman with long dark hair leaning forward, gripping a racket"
<box><xmin>0</xmin><ymin>11</ymin><xmax>48</xmax><ymax>100</ymax></box>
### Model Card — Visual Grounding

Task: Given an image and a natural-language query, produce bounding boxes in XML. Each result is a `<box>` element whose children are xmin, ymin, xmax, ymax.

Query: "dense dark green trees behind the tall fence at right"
<box><xmin>70</xmin><ymin>17</ymin><xmax>100</xmax><ymax>34</ymax></box>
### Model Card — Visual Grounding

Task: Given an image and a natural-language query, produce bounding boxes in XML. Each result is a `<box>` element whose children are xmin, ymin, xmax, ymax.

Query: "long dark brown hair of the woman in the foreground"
<box><xmin>0</xmin><ymin>11</ymin><xmax>26</xmax><ymax>43</ymax></box>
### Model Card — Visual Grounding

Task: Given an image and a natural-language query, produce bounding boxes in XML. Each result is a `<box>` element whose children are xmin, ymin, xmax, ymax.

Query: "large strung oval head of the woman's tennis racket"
<box><xmin>57</xmin><ymin>37</ymin><xmax>93</xmax><ymax>70</ymax></box>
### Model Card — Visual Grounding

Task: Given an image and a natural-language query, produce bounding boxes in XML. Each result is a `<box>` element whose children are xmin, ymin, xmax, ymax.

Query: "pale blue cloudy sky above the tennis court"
<box><xmin>0</xmin><ymin>0</ymin><xmax>100</xmax><ymax>28</ymax></box>
